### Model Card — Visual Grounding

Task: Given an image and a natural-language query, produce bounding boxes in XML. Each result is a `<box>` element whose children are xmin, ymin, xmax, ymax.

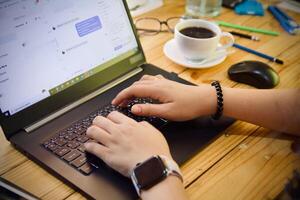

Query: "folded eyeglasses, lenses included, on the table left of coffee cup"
<box><xmin>135</xmin><ymin>17</ymin><xmax>186</xmax><ymax>35</ymax></box>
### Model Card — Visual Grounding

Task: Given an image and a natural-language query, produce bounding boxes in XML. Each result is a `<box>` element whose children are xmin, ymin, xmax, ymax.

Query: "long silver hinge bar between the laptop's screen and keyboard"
<box><xmin>25</xmin><ymin>67</ymin><xmax>143</xmax><ymax>133</ymax></box>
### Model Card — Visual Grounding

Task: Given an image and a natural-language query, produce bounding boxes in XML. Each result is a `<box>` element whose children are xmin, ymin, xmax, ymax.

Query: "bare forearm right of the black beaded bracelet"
<box><xmin>223</xmin><ymin>88</ymin><xmax>300</xmax><ymax>135</ymax></box>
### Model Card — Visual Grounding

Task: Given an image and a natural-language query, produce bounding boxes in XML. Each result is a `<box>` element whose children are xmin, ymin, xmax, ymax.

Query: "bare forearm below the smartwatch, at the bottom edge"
<box><xmin>141</xmin><ymin>176</ymin><xmax>187</xmax><ymax>200</ymax></box>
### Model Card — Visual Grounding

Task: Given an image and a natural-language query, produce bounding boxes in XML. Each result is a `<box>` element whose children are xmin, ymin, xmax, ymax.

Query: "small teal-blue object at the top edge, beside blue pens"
<box><xmin>234</xmin><ymin>0</ymin><xmax>264</xmax><ymax>16</ymax></box>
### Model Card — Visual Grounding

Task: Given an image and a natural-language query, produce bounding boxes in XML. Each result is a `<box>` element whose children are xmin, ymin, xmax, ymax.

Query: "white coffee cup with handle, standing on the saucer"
<box><xmin>175</xmin><ymin>19</ymin><xmax>234</xmax><ymax>61</ymax></box>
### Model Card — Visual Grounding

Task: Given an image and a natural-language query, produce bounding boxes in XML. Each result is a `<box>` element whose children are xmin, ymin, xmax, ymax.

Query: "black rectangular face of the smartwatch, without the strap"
<box><xmin>134</xmin><ymin>157</ymin><xmax>167</xmax><ymax>189</ymax></box>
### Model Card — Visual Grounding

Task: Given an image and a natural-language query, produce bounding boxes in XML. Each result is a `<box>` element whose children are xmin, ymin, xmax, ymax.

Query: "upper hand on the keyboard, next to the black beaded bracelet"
<box><xmin>112</xmin><ymin>75</ymin><xmax>216</xmax><ymax>121</ymax></box>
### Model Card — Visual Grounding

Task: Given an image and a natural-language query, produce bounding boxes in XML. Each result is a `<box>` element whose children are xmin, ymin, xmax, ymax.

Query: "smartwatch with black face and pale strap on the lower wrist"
<box><xmin>131</xmin><ymin>155</ymin><xmax>183</xmax><ymax>196</ymax></box>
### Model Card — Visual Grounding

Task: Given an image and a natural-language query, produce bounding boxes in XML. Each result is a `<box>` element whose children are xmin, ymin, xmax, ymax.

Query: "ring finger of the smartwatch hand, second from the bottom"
<box><xmin>86</xmin><ymin>126</ymin><xmax>111</xmax><ymax>146</ymax></box>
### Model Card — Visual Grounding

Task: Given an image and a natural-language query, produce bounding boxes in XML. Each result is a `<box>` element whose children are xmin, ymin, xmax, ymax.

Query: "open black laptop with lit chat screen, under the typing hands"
<box><xmin>0</xmin><ymin>0</ymin><xmax>233</xmax><ymax>200</ymax></box>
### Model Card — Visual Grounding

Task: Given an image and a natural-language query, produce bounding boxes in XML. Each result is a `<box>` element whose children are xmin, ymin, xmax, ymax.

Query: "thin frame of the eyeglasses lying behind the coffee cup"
<box><xmin>134</xmin><ymin>16</ymin><xmax>188</xmax><ymax>35</ymax></box>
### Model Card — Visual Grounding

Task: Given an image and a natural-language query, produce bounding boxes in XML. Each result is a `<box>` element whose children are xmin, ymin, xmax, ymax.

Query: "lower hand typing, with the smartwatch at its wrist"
<box><xmin>85</xmin><ymin>111</ymin><xmax>172</xmax><ymax>177</ymax></box>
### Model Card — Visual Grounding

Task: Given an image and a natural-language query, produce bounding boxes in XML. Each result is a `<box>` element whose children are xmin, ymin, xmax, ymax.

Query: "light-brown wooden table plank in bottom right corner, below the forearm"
<box><xmin>187</xmin><ymin>128</ymin><xmax>300</xmax><ymax>200</ymax></box>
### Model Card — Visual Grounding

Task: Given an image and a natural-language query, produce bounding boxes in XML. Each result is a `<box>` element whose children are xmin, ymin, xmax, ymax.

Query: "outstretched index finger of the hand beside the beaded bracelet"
<box><xmin>112</xmin><ymin>85</ymin><xmax>159</xmax><ymax>105</ymax></box>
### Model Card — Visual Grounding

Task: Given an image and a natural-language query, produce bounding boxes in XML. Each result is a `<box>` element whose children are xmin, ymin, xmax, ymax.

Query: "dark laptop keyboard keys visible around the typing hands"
<box><xmin>42</xmin><ymin>98</ymin><xmax>166</xmax><ymax>175</ymax></box>
